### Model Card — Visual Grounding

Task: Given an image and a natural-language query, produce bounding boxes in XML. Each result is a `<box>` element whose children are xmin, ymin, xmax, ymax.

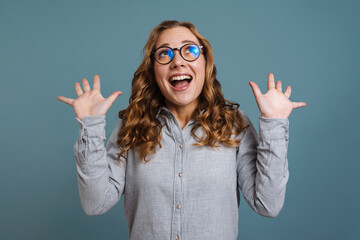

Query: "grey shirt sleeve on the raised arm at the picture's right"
<box><xmin>237</xmin><ymin>111</ymin><xmax>289</xmax><ymax>217</ymax></box>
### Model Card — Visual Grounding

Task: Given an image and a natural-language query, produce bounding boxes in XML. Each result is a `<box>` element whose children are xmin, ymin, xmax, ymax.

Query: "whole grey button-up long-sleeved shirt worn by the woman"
<box><xmin>74</xmin><ymin>108</ymin><xmax>289</xmax><ymax>240</ymax></box>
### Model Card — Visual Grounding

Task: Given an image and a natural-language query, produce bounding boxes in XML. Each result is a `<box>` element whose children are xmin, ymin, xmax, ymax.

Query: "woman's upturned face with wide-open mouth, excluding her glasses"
<box><xmin>154</xmin><ymin>27</ymin><xmax>206</xmax><ymax>110</ymax></box>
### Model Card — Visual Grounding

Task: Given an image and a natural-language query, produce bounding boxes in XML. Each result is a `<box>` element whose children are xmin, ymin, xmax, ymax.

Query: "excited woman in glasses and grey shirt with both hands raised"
<box><xmin>58</xmin><ymin>21</ymin><xmax>306</xmax><ymax>240</ymax></box>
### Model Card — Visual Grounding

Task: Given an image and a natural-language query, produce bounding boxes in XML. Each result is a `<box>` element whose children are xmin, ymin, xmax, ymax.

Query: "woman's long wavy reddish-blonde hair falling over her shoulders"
<box><xmin>117</xmin><ymin>21</ymin><xmax>247</xmax><ymax>162</ymax></box>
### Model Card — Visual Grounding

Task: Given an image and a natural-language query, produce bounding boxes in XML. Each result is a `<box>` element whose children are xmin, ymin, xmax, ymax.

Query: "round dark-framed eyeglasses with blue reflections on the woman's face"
<box><xmin>152</xmin><ymin>44</ymin><xmax>203</xmax><ymax>65</ymax></box>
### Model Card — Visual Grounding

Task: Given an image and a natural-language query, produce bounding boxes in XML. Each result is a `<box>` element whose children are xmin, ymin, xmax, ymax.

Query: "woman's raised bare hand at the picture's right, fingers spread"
<box><xmin>249</xmin><ymin>73</ymin><xmax>306</xmax><ymax>118</ymax></box>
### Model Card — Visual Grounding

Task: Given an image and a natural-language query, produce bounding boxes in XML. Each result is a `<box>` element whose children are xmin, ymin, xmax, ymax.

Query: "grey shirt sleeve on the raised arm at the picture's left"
<box><xmin>74</xmin><ymin>116</ymin><xmax>126</xmax><ymax>215</ymax></box>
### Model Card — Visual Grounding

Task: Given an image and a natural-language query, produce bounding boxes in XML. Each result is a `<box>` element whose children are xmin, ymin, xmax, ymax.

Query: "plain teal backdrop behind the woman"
<box><xmin>0</xmin><ymin>0</ymin><xmax>360</xmax><ymax>240</ymax></box>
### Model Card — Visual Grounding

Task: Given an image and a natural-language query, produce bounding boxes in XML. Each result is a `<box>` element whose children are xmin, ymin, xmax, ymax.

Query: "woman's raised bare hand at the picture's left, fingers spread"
<box><xmin>57</xmin><ymin>75</ymin><xmax>122</xmax><ymax>120</ymax></box>
